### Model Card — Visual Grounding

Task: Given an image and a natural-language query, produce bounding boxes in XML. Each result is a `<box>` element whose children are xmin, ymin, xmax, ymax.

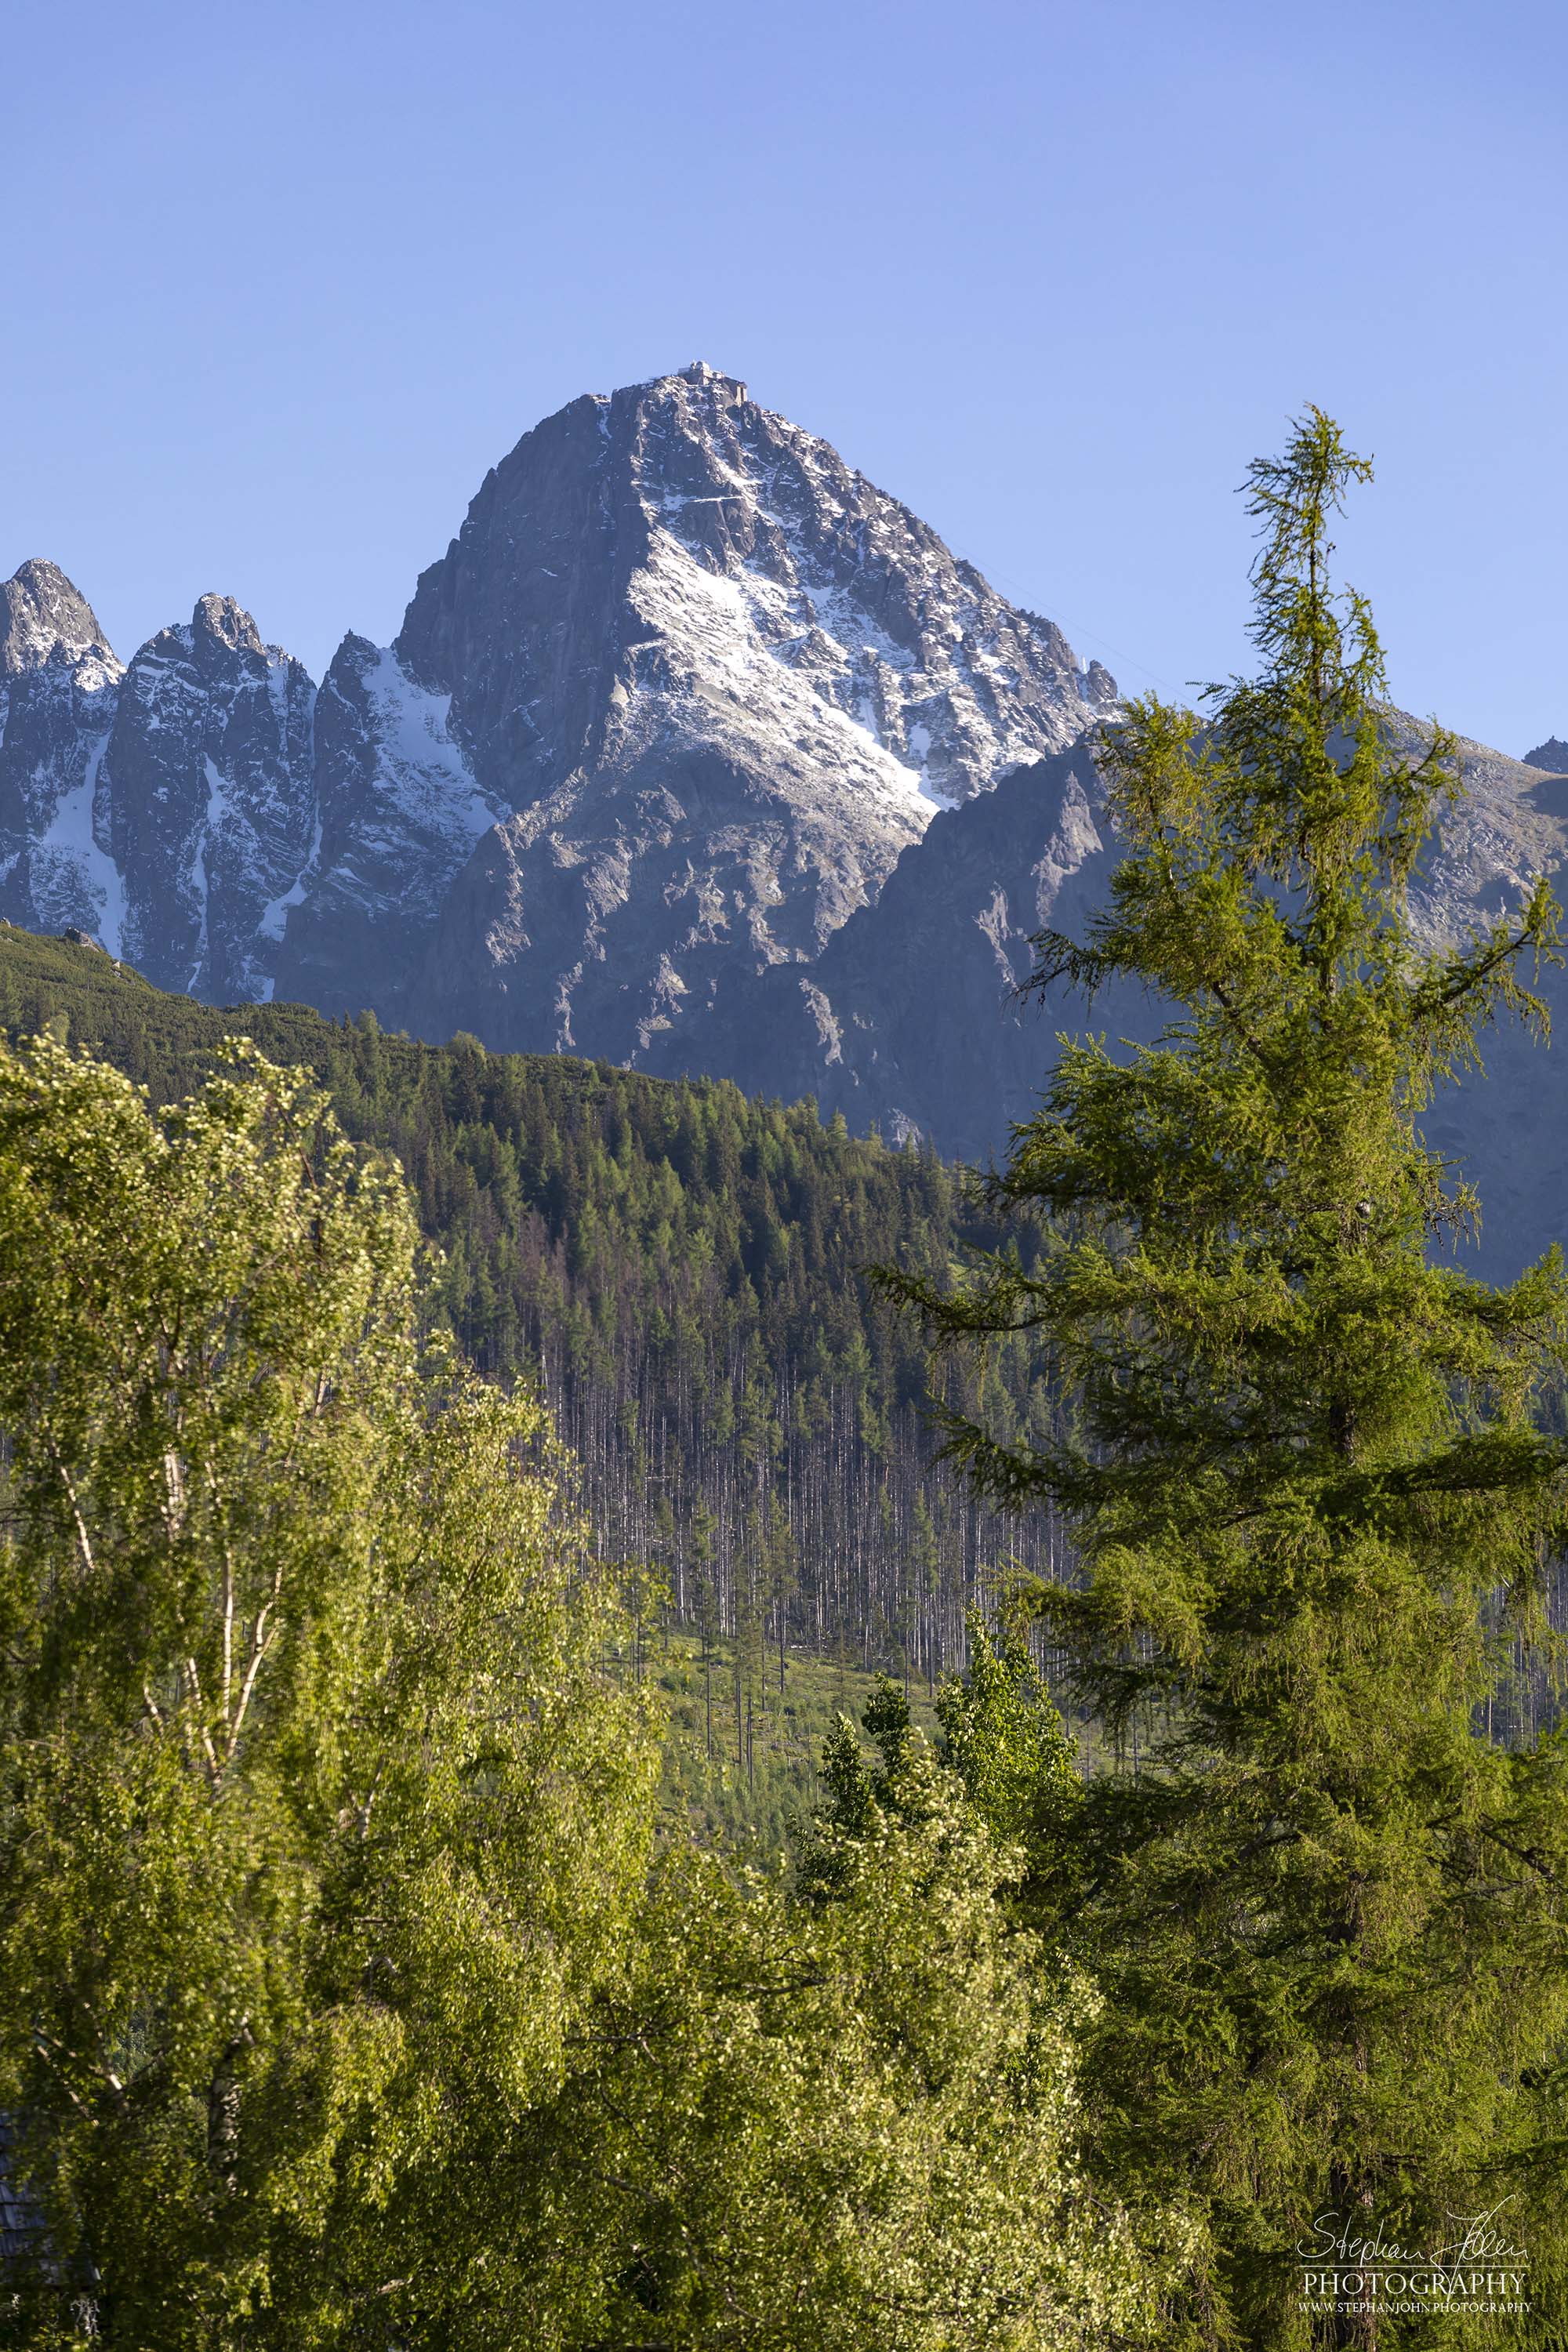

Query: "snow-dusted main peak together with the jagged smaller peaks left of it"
<box><xmin>0</xmin><ymin>365</ymin><xmax>1116</xmax><ymax>1058</ymax></box>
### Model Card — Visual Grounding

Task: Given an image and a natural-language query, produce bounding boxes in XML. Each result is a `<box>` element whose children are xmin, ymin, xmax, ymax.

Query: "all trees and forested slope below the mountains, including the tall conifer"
<box><xmin>0</xmin><ymin>409</ymin><xmax>1568</xmax><ymax>2352</ymax></box>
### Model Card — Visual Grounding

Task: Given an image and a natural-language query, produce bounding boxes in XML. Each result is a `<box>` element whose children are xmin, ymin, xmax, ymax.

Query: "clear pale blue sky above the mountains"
<box><xmin>0</xmin><ymin>0</ymin><xmax>1568</xmax><ymax>753</ymax></box>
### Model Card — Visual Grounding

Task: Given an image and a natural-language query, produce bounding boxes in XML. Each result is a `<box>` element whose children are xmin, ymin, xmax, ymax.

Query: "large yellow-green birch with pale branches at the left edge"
<box><xmin>0</xmin><ymin>1040</ymin><xmax>659</xmax><ymax>2352</ymax></box>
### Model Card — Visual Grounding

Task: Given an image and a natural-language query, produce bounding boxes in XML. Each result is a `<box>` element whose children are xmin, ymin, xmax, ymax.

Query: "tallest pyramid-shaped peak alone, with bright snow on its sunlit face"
<box><xmin>280</xmin><ymin>367</ymin><xmax>1114</xmax><ymax>1061</ymax></box>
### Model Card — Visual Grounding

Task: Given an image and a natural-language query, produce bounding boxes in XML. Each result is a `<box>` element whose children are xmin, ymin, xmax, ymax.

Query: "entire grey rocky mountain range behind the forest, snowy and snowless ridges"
<box><xmin>0</xmin><ymin>362</ymin><xmax>1568</xmax><ymax>1272</ymax></box>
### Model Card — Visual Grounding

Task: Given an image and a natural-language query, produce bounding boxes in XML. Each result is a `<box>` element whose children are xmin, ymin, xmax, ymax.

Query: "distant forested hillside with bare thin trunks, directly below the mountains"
<box><xmin>0</xmin><ymin>927</ymin><xmax>1055</xmax><ymax>1682</ymax></box>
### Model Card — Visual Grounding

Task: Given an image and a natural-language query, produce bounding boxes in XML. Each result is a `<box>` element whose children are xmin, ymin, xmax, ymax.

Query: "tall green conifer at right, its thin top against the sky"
<box><xmin>886</xmin><ymin>409</ymin><xmax>1568</xmax><ymax>2352</ymax></box>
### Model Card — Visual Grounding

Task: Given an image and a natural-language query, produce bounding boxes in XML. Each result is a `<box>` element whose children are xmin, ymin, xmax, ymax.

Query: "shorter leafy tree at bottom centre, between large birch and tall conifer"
<box><xmin>517</xmin><ymin>1686</ymin><xmax>1175</xmax><ymax>2352</ymax></box>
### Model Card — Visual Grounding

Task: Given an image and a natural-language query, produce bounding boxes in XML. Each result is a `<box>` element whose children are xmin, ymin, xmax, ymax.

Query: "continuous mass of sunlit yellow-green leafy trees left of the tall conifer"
<box><xmin>0</xmin><ymin>1035</ymin><xmax>1154</xmax><ymax>2352</ymax></box>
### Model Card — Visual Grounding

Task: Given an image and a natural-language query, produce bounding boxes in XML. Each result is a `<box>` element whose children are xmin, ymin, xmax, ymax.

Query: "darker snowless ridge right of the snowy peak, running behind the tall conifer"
<box><xmin>667</xmin><ymin>713</ymin><xmax>1568</xmax><ymax>1277</ymax></box>
